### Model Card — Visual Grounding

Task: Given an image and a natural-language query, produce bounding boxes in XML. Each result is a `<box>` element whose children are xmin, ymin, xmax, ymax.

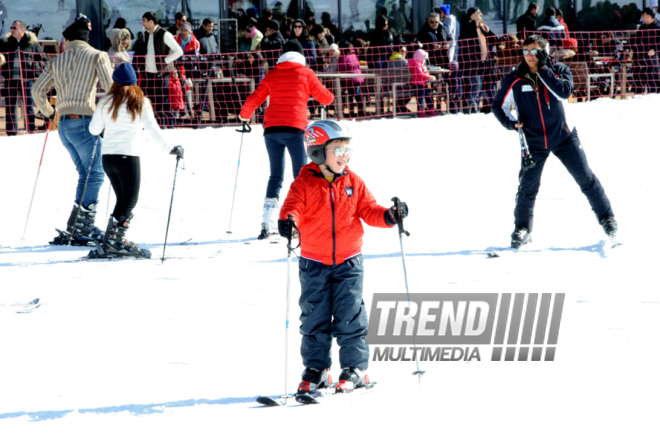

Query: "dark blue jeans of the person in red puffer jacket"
<box><xmin>264</xmin><ymin>131</ymin><xmax>307</xmax><ymax>200</ymax></box>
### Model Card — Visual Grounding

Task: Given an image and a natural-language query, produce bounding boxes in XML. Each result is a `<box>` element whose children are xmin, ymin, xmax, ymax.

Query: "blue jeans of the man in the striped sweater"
<box><xmin>57</xmin><ymin>118</ymin><xmax>105</xmax><ymax>207</ymax></box>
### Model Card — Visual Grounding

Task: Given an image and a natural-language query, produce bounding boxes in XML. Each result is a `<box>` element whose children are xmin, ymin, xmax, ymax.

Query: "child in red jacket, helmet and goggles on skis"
<box><xmin>278</xmin><ymin>120</ymin><xmax>408</xmax><ymax>394</ymax></box>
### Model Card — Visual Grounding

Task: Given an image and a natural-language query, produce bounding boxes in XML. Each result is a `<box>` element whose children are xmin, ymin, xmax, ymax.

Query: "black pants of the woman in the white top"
<box><xmin>103</xmin><ymin>154</ymin><xmax>140</xmax><ymax>222</ymax></box>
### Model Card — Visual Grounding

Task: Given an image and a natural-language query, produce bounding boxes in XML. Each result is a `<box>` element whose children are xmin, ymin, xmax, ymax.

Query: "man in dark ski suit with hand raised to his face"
<box><xmin>493</xmin><ymin>34</ymin><xmax>617</xmax><ymax>248</ymax></box>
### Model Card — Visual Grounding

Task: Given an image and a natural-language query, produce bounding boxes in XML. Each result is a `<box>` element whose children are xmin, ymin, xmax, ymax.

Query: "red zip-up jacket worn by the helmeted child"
<box><xmin>280</xmin><ymin>163</ymin><xmax>393</xmax><ymax>265</ymax></box>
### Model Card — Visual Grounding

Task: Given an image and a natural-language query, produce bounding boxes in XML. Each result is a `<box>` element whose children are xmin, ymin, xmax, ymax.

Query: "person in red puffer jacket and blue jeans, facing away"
<box><xmin>239</xmin><ymin>40</ymin><xmax>334</xmax><ymax>239</ymax></box>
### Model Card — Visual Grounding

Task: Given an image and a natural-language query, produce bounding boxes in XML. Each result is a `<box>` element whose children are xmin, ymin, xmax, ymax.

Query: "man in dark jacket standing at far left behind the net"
<box><xmin>0</xmin><ymin>21</ymin><xmax>47</xmax><ymax>136</ymax></box>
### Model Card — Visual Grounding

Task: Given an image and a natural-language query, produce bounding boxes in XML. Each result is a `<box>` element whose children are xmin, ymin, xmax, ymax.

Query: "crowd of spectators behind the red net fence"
<box><xmin>0</xmin><ymin>3</ymin><xmax>660</xmax><ymax>135</ymax></box>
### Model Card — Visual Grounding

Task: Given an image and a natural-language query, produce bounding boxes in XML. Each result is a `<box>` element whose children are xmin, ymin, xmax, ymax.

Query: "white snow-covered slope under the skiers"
<box><xmin>0</xmin><ymin>95</ymin><xmax>660</xmax><ymax>439</ymax></box>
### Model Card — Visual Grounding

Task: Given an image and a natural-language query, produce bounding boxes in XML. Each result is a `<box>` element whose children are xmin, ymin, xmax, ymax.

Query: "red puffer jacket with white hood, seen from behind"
<box><xmin>241</xmin><ymin>52</ymin><xmax>334</xmax><ymax>130</ymax></box>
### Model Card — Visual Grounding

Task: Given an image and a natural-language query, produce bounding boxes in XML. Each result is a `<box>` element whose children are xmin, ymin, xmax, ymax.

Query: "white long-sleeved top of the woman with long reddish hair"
<box><xmin>89</xmin><ymin>95</ymin><xmax>172</xmax><ymax>156</ymax></box>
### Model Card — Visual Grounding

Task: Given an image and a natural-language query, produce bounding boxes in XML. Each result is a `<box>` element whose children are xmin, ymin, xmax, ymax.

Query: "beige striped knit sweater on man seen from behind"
<box><xmin>32</xmin><ymin>40</ymin><xmax>112</xmax><ymax>116</ymax></box>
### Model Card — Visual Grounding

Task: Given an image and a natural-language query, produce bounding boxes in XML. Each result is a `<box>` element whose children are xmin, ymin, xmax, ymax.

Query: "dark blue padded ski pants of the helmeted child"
<box><xmin>299</xmin><ymin>255</ymin><xmax>369</xmax><ymax>370</ymax></box>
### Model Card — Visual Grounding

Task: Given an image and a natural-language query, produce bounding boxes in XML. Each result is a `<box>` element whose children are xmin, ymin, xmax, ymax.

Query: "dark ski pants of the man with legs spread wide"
<box><xmin>514</xmin><ymin>131</ymin><xmax>614</xmax><ymax>232</ymax></box>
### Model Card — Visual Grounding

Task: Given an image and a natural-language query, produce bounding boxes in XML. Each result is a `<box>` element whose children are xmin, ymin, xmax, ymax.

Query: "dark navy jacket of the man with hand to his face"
<box><xmin>492</xmin><ymin>61</ymin><xmax>573</xmax><ymax>149</ymax></box>
